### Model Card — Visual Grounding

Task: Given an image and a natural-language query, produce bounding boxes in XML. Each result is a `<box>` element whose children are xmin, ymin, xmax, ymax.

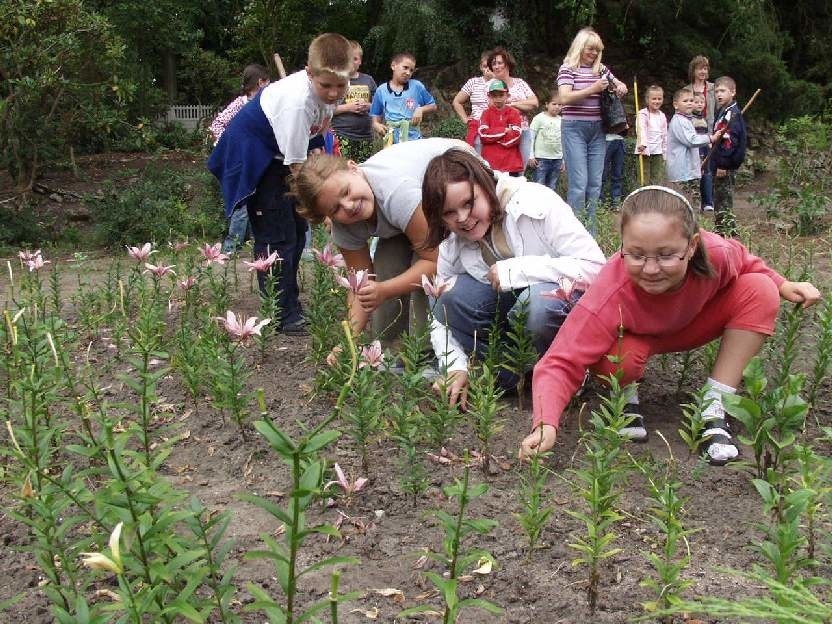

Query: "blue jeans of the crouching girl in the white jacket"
<box><xmin>433</xmin><ymin>273</ymin><xmax>577</xmax><ymax>388</ymax></box>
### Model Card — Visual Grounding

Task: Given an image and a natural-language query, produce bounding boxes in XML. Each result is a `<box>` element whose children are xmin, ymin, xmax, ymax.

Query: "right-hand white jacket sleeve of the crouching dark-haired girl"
<box><xmin>495</xmin><ymin>185</ymin><xmax>606</xmax><ymax>291</ymax></box>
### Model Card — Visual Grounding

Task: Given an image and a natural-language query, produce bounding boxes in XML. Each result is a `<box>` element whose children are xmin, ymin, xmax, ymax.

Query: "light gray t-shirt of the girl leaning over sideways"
<box><xmin>332</xmin><ymin>138</ymin><xmax>471</xmax><ymax>250</ymax></box>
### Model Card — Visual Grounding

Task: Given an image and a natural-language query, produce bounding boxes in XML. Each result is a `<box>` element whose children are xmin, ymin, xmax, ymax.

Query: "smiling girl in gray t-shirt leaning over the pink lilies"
<box><xmin>297</xmin><ymin>138</ymin><xmax>470</xmax><ymax>336</ymax></box>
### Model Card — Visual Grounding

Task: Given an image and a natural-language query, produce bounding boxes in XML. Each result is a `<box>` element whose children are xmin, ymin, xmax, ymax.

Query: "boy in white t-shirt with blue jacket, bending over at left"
<box><xmin>208</xmin><ymin>33</ymin><xmax>353</xmax><ymax>335</ymax></box>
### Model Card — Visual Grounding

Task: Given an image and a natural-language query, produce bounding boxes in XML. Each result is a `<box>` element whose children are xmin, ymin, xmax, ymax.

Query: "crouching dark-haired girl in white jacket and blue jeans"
<box><xmin>422</xmin><ymin>149</ymin><xmax>606</xmax><ymax>408</ymax></box>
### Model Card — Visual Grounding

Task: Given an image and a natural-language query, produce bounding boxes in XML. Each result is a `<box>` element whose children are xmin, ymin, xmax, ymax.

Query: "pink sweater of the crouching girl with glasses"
<box><xmin>532</xmin><ymin>230</ymin><xmax>785</xmax><ymax>427</ymax></box>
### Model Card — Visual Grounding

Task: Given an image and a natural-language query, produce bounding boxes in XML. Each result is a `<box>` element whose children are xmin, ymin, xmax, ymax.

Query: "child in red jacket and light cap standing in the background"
<box><xmin>478</xmin><ymin>78</ymin><xmax>524</xmax><ymax>176</ymax></box>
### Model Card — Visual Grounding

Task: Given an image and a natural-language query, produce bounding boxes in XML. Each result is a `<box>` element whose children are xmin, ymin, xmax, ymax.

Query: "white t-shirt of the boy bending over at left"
<box><xmin>260</xmin><ymin>69</ymin><xmax>335</xmax><ymax>165</ymax></box>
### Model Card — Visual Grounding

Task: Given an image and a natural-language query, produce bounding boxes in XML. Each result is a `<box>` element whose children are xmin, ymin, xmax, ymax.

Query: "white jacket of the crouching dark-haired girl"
<box><xmin>431</xmin><ymin>175</ymin><xmax>606</xmax><ymax>371</ymax></box>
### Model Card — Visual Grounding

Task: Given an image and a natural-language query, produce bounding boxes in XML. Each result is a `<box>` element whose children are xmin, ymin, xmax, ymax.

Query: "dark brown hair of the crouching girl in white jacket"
<box><xmin>422</xmin><ymin>148</ymin><xmax>503</xmax><ymax>249</ymax></box>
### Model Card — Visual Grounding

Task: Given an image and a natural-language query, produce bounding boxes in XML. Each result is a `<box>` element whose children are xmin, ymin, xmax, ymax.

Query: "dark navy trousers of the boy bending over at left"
<box><xmin>248</xmin><ymin>160</ymin><xmax>308</xmax><ymax>326</ymax></box>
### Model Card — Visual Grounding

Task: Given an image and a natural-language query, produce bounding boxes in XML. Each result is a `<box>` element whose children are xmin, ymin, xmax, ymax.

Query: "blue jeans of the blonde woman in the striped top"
<box><xmin>560</xmin><ymin>119</ymin><xmax>607</xmax><ymax>236</ymax></box>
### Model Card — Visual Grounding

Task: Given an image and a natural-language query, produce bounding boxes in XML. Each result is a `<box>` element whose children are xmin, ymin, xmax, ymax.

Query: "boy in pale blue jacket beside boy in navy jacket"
<box><xmin>667</xmin><ymin>87</ymin><xmax>710</xmax><ymax>204</ymax></box>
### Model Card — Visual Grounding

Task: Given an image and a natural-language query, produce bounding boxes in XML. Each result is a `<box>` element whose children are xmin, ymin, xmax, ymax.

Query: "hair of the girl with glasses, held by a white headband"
<box><xmin>621</xmin><ymin>188</ymin><xmax>716</xmax><ymax>279</ymax></box>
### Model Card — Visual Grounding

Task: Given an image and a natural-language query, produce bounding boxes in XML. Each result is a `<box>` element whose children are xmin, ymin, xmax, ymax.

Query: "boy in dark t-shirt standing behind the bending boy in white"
<box><xmin>332</xmin><ymin>41</ymin><xmax>376</xmax><ymax>162</ymax></box>
